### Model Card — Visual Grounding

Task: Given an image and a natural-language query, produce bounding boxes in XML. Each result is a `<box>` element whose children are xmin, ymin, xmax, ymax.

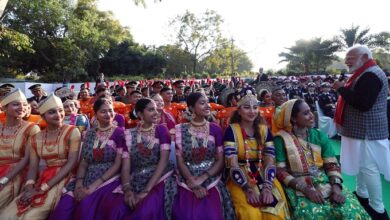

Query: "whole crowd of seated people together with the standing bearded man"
<box><xmin>0</xmin><ymin>45</ymin><xmax>390</xmax><ymax>220</ymax></box>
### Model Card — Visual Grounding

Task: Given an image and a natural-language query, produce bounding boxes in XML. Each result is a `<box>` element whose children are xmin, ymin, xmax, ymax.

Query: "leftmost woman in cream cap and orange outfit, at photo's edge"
<box><xmin>0</xmin><ymin>89</ymin><xmax>39</xmax><ymax>213</ymax></box>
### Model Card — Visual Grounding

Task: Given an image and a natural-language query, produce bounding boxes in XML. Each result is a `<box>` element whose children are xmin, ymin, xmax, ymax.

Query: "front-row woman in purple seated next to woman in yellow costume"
<box><xmin>172</xmin><ymin>93</ymin><xmax>235</xmax><ymax>220</ymax></box>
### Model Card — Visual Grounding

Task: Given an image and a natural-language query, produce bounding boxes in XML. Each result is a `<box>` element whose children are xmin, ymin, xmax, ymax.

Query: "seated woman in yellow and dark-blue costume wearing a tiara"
<box><xmin>224</xmin><ymin>88</ymin><xmax>289</xmax><ymax>219</ymax></box>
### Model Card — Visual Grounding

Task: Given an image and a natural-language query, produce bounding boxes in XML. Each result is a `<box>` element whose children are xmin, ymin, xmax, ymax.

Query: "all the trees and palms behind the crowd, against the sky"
<box><xmin>0</xmin><ymin>0</ymin><xmax>390</xmax><ymax>79</ymax></box>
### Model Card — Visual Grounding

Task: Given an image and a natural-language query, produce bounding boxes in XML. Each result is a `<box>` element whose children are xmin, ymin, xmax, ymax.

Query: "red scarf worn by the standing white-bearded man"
<box><xmin>334</xmin><ymin>59</ymin><xmax>376</xmax><ymax>125</ymax></box>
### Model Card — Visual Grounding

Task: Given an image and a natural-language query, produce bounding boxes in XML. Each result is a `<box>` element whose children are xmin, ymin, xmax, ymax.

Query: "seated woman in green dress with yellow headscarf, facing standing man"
<box><xmin>274</xmin><ymin>99</ymin><xmax>370</xmax><ymax>220</ymax></box>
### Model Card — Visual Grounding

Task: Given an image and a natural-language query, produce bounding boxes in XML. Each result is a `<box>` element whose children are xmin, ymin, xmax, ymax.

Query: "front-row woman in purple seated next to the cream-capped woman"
<box><xmin>50</xmin><ymin>98</ymin><xmax>125</xmax><ymax>220</ymax></box>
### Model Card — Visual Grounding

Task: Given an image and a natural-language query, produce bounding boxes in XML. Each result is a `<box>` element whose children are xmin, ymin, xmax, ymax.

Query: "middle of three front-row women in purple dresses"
<box><xmin>104</xmin><ymin>98</ymin><xmax>176</xmax><ymax>219</ymax></box>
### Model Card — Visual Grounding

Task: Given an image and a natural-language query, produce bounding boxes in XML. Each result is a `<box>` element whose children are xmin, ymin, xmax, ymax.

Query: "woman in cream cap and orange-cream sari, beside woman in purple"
<box><xmin>0</xmin><ymin>95</ymin><xmax>81</xmax><ymax>220</ymax></box>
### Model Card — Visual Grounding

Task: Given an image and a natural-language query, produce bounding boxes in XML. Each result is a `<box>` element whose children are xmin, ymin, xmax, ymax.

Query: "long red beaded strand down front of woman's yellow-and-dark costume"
<box><xmin>241</xmin><ymin>128</ymin><xmax>263</xmax><ymax>185</ymax></box>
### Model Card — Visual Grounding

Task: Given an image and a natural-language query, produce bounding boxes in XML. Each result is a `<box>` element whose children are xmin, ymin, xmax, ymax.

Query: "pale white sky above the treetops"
<box><xmin>99</xmin><ymin>0</ymin><xmax>390</xmax><ymax>71</ymax></box>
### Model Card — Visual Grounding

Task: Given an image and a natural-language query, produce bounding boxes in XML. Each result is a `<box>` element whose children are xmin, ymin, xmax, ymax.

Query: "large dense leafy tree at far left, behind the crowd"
<box><xmin>0</xmin><ymin>0</ymin><xmax>132</xmax><ymax>81</ymax></box>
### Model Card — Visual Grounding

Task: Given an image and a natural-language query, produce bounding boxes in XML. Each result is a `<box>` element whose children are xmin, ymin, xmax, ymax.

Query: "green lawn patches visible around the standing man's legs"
<box><xmin>330</xmin><ymin>139</ymin><xmax>390</xmax><ymax>212</ymax></box>
